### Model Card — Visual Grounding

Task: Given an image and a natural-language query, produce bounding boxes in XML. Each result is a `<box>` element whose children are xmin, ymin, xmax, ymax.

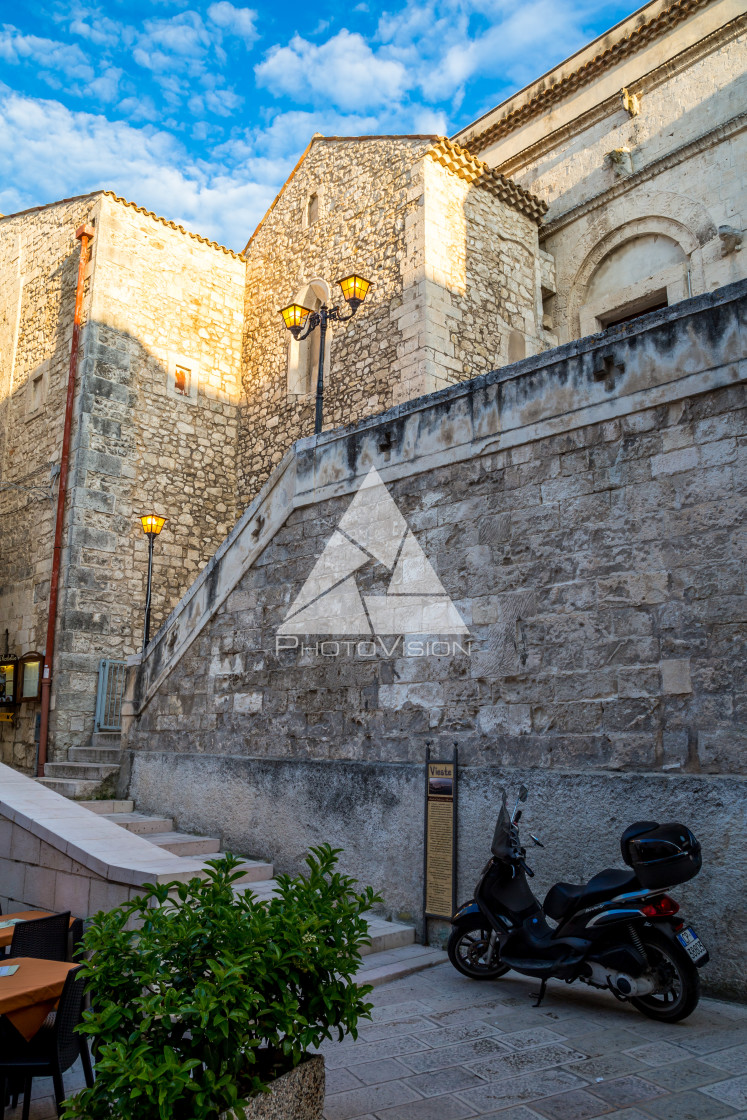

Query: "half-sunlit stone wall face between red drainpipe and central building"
<box><xmin>53</xmin><ymin>197</ymin><xmax>244</xmax><ymax>749</ymax></box>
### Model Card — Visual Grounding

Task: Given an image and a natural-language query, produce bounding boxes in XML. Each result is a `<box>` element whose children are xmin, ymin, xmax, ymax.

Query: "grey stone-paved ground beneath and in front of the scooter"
<box><xmin>323</xmin><ymin>964</ymin><xmax>747</xmax><ymax>1120</ymax></box>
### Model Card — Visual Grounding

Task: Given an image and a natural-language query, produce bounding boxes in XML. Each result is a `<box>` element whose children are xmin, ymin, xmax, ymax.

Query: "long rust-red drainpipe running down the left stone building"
<box><xmin>36</xmin><ymin>225</ymin><xmax>94</xmax><ymax>777</ymax></box>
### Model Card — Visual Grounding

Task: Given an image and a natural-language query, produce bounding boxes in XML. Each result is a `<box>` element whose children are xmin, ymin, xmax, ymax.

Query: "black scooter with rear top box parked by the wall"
<box><xmin>448</xmin><ymin>786</ymin><xmax>709</xmax><ymax>1023</ymax></box>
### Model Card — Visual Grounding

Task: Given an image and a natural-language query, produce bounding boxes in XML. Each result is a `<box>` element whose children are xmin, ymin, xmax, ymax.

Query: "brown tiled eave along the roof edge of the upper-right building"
<box><xmin>468</xmin><ymin>0</ymin><xmax>712</xmax><ymax>151</ymax></box>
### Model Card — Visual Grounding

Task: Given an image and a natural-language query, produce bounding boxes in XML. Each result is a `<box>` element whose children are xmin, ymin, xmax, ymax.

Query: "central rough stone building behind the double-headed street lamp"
<box><xmin>240</xmin><ymin>137</ymin><xmax>542</xmax><ymax>505</ymax></box>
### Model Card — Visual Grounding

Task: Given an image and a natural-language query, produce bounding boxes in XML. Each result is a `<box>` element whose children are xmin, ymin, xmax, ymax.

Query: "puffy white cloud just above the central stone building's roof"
<box><xmin>254</xmin><ymin>29</ymin><xmax>409</xmax><ymax>112</ymax></box>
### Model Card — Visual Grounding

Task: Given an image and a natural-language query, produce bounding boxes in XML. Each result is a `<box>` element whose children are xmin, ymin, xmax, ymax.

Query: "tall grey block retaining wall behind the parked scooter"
<box><xmin>127</xmin><ymin>283</ymin><xmax>747</xmax><ymax>992</ymax></box>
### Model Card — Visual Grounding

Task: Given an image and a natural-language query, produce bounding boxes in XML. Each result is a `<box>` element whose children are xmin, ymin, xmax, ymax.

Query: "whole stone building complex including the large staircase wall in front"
<box><xmin>0</xmin><ymin>0</ymin><xmax>747</xmax><ymax>992</ymax></box>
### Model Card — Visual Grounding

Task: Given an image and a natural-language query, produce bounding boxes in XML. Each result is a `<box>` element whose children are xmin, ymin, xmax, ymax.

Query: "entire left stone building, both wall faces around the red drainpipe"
<box><xmin>0</xmin><ymin>195</ymin><xmax>244</xmax><ymax>768</ymax></box>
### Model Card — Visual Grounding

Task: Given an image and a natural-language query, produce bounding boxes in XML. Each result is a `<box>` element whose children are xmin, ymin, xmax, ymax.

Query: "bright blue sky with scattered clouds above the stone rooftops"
<box><xmin>0</xmin><ymin>0</ymin><xmax>637</xmax><ymax>249</ymax></box>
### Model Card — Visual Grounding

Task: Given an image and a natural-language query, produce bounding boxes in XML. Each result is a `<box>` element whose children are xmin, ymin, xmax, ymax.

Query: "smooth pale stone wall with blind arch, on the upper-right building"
<box><xmin>458</xmin><ymin>0</ymin><xmax>747</xmax><ymax>342</ymax></box>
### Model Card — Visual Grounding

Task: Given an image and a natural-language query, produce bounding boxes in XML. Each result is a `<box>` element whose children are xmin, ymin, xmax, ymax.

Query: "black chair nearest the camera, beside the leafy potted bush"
<box><xmin>0</xmin><ymin>967</ymin><xmax>93</xmax><ymax>1120</ymax></box>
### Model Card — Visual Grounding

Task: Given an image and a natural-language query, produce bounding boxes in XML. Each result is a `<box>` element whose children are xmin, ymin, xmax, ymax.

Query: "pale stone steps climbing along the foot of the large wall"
<box><xmin>78</xmin><ymin>797</ymin><xmax>446</xmax><ymax>987</ymax></box>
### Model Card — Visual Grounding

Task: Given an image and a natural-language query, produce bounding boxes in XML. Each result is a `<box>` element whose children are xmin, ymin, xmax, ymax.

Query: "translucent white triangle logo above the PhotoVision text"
<box><xmin>278</xmin><ymin>467</ymin><xmax>469</xmax><ymax>636</ymax></box>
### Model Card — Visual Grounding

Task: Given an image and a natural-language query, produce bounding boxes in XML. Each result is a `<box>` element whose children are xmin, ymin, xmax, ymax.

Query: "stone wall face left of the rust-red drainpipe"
<box><xmin>0</xmin><ymin>196</ymin><xmax>97</xmax><ymax>766</ymax></box>
